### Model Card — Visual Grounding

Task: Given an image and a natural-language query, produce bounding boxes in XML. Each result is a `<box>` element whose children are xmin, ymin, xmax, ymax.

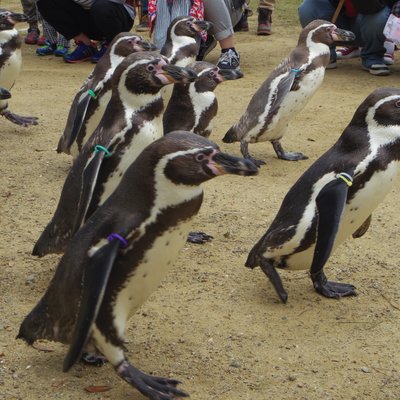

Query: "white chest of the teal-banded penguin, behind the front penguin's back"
<box><xmin>99</xmin><ymin>117</ymin><xmax>162</xmax><ymax>205</ymax></box>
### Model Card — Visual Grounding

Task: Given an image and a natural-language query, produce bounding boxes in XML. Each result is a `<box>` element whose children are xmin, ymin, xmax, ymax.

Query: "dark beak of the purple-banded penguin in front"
<box><xmin>207</xmin><ymin>152</ymin><xmax>258</xmax><ymax>176</ymax></box>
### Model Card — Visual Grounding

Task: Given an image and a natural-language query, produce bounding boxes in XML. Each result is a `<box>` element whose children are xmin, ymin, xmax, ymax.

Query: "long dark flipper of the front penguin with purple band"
<box><xmin>63</xmin><ymin>239</ymin><xmax>120</xmax><ymax>372</ymax></box>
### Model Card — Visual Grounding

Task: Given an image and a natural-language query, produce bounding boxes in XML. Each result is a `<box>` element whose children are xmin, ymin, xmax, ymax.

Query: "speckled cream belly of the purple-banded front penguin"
<box><xmin>110</xmin><ymin>220</ymin><xmax>190</xmax><ymax>337</ymax></box>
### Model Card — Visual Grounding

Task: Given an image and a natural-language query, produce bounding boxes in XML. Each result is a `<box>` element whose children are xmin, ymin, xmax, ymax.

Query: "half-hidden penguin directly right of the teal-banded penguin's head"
<box><xmin>163</xmin><ymin>61</ymin><xmax>243</xmax><ymax>137</ymax></box>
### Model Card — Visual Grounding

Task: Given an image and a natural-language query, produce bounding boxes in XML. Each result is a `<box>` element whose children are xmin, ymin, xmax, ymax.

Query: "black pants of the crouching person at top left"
<box><xmin>37</xmin><ymin>0</ymin><xmax>133</xmax><ymax>42</ymax></box>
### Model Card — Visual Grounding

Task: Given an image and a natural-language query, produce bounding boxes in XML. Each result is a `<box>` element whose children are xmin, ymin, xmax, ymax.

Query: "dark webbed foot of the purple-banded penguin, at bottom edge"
<box><xmin>116</xmin><ymin>360</ymin><xmax>189</xmax><ymax>400</ymax></box>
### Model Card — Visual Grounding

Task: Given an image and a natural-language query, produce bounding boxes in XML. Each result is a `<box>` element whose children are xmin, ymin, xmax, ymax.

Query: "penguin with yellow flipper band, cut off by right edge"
<box><xmin>245</xmin><ymin>88</ymin><xmax>400</xmax><ymax>302</ymax></box>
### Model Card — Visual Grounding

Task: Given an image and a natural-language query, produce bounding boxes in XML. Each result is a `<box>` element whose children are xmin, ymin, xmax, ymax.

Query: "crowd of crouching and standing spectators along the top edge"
<box><xmin>21</xmin><ymin>0</ymin><xmax>400</xmax><ymax>76</ymax></box>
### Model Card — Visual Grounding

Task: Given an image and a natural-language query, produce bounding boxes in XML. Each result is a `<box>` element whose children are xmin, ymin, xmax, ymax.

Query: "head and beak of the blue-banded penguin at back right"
<box><xmin>299</xmin><ymin>19</ymin><xmax>355</xmax><ymax>46</ymax></box>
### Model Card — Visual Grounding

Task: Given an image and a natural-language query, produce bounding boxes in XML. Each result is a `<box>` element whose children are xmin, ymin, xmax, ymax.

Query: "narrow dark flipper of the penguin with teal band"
<box><xmin>73</xmin><ymin>151</ymin><xmax>105</xmax><ymax>232</ymax></box>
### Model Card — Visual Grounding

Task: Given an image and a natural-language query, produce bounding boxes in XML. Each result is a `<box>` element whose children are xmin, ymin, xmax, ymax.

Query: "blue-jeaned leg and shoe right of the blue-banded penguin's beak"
<box><xmin>354</xmin><ymin>7</ymin><xmax>390</xmax><ymax>75</ymax></box>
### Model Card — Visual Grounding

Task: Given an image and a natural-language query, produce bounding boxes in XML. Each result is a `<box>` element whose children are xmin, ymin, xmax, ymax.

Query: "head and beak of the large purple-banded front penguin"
<box><xmin>153</xmin><ymin>131</ymin><xmax>258</xmax><ymax>186</ymax></box>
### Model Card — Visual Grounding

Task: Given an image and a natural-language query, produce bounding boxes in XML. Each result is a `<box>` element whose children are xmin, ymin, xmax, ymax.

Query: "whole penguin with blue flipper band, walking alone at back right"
<box><xmin>222</xmin><ymin>20</ymin><xmax>355</xmax><ymax>166</ymax></box>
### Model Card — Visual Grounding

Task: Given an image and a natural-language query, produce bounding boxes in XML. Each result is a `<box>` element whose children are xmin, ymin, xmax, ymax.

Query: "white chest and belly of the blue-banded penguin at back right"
<box><xmin>253</xmin><ymin>67</ymin><xmax>325</xmax><ymax>141</ymax></box>
